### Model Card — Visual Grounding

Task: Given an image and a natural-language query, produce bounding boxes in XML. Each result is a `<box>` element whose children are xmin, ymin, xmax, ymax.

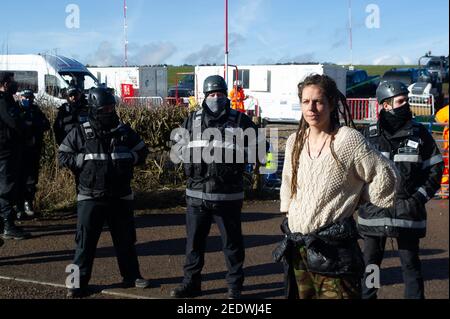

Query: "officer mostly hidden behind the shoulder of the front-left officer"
<box><xmin>53</xmin><ymin>86</ymin><xmax>88</xmax><ymax>145</ymax></box>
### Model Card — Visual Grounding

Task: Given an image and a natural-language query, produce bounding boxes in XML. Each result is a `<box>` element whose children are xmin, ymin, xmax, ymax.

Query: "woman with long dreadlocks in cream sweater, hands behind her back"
<box><xmin>274</xmin><ymin>75</ymin><xmax>397</xmax><ymax>299</ymax></box>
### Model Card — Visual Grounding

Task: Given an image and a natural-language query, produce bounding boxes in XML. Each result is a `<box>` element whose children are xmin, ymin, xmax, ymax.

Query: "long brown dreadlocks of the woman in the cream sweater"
<box><xmin>291</xmin><ymin>74</ymin><xmax>355</xmax><ymax>198</ymax></box>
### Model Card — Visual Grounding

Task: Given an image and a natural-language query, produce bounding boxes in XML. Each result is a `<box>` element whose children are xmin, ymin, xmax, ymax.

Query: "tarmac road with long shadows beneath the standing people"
<box><xmin>0</xmin><ymin>200</ymin><xmax>449</xmax><ymax>299</ymax></box>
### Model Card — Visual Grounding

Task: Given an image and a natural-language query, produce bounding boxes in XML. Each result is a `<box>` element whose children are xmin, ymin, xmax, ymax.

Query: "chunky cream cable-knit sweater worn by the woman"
<box><xmin>280</xmin><ymin>127</ymin><xmax>398</xmax><ymax>234</ymax></box>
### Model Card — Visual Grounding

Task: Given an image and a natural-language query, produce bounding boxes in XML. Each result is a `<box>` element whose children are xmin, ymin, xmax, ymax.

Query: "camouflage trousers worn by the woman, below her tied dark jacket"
<box><xmin>292</xmin><ymin>247</ymin><xmax>361</xmax><ymax>299</ymax></box>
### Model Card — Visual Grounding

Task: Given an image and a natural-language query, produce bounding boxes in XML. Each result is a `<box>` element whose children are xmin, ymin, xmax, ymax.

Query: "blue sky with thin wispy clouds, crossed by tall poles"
<box><xmin>0</xmin><ymin>0</ymin><xmax>449</xmax><ymax>66</ymax></box>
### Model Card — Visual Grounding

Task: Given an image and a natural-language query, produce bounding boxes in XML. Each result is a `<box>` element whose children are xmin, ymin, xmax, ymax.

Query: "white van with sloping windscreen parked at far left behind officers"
<box><xmin>0</xmin><ymin>54</ymin><xmax>98</xmax><ymax>107</ymax></box>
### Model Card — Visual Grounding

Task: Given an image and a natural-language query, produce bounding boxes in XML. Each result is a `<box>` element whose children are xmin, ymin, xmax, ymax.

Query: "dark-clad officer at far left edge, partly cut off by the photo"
<box><xmin>0</xmin><ymin>72</ymin><xmax>30</xmax><ymax>240</ymax></box>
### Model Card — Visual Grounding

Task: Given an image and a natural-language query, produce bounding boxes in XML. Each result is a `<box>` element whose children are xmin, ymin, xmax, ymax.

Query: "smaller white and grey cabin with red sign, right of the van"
<box><xmin>88</xmin><ymin>66</ymin><xmax>167</xmax><ymax>98</ymax></box>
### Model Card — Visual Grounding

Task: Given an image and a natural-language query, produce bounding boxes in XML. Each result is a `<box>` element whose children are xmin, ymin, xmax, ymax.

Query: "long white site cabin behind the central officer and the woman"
<box><xmin>195</xmin><ymin>64</ymin><xmax>347</xmax><ymax>123</ymax></box>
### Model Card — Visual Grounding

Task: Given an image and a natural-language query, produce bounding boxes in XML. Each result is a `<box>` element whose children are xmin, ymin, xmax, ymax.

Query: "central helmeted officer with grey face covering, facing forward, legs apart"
<box><xmin>171</xmin><ymin>75</ymin><xmax>264</xmax><ymax>298</ymax></box>
